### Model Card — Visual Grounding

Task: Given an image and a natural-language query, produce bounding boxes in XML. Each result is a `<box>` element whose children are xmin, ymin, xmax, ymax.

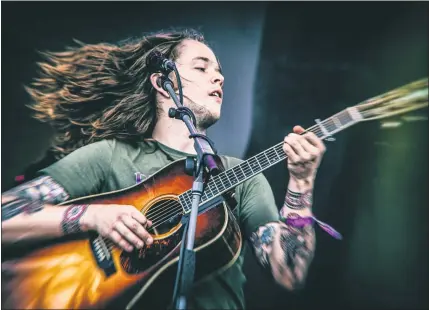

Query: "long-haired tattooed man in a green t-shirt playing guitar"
<box><xmin>2</xmin><ymin>31</ymin><xmax>325</xmax><ymax>309</ymax></box>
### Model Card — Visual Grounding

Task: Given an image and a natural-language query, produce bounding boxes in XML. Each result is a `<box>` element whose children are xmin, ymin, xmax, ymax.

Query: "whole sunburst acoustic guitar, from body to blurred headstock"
<box><xmin>2</xmin><ymin>78</ymin><xmax>428</xmax><ymax>310</ymax></box>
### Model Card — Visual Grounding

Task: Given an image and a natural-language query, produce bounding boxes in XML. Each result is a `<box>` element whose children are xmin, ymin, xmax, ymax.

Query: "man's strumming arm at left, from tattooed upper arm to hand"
<box><xmin>1</xmin><ymin>176</ymin><xmax>152</xmax><ymax>251</ymax></box>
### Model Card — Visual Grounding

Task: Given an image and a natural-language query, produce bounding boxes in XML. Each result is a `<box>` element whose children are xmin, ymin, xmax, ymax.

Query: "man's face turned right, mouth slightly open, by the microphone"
<box><xmin>171</xmin><ymin>40</ymin><xmax>224</xmax><ymax>130</ymax></box>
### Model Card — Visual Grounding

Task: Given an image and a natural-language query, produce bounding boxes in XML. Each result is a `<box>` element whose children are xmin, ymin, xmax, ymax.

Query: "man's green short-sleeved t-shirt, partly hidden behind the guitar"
<box><xmin>41</xmin><ymin>140</ymin><xmax>279</xmax><ymax>309</ymax></box>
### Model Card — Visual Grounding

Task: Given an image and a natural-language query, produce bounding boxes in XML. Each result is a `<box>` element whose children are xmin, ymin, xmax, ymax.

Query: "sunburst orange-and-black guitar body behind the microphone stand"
<box><xmin>2</xmin><ymin>160</ymin><xmax>242</xmax><ymax>310</ymax></box>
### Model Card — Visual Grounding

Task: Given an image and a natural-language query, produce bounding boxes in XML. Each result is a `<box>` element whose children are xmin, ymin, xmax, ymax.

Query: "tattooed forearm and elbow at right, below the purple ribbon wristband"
<box><xmin>251</xmin><ymin>222</ymin><xmax>315</xmax><ymax>290</ymax></box>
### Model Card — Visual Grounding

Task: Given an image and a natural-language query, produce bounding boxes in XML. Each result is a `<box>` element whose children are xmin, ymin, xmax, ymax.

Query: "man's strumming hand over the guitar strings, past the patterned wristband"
<box><xmin>80</xmin><ymin>205</ymin><xmax>153</xmax><ymax>252</ymax></box>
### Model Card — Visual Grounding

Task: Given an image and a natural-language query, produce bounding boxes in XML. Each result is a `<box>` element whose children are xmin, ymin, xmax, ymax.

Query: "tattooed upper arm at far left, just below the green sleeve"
<box><xmin>1</xmin><ymin>176</ymin><xmax>69</xmax><ymax>222</ymax></box>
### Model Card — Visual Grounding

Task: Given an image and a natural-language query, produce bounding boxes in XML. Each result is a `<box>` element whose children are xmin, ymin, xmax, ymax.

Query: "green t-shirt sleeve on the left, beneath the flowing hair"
<box><xmin>39</xmin><ymin>140</ymin><xmax>113</xmax><ymax>199</ymax></box>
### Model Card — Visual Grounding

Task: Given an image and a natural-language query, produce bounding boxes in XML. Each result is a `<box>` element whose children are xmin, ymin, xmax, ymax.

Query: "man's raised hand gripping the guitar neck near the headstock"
<box><xmin>283</xmin><ymin>126</ymin><xmax>326</xmax><ymax>180</ymax></box>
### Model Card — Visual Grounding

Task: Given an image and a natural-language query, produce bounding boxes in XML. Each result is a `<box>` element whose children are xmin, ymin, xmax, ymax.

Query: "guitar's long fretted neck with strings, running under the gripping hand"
<box><xmin>179</xmin><ymin>108</ymin><xmax>362</xmax><ymax>213</ymax></box>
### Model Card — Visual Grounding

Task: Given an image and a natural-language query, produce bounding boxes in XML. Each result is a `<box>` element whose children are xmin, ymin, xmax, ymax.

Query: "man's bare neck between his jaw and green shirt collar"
<box><xmin>152</xmin><ymin>113</ymin><xmax>205</xmax><ymax>154</ymax></box>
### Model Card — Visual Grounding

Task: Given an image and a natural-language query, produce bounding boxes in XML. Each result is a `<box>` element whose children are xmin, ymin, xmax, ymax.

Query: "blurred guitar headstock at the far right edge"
<box><xmin>354</xmin><ymin>78</ymin><xmax>428</xmax><ymax>121</ymax></box>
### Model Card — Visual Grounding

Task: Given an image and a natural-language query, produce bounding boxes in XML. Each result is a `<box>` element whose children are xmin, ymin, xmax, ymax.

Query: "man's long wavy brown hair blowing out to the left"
<box><xmin>26</xmin><ymin>30</ymin><xmax>207</xmax><ymax>159</ymax></box>
